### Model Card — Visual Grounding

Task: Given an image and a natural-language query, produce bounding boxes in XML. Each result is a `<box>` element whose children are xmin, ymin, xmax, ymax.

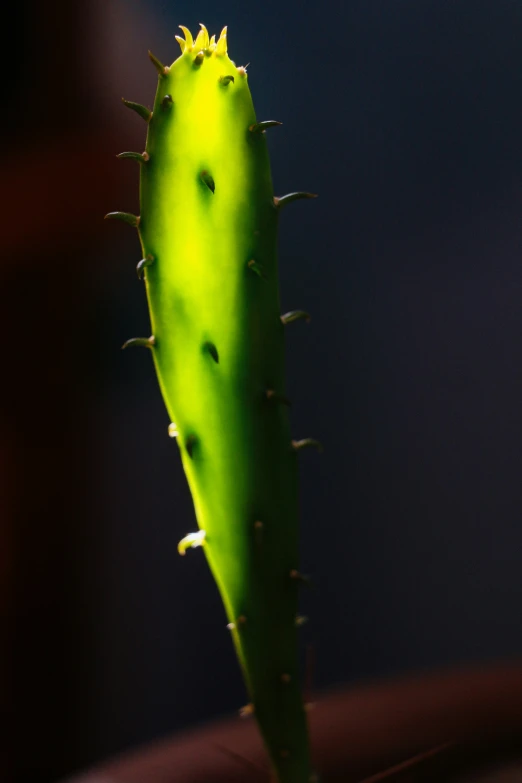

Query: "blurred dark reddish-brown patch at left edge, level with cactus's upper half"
<box><xmin>2</xmin><ymin>135</ymin><xmax>136</xmax><ymax>264</ymax></box>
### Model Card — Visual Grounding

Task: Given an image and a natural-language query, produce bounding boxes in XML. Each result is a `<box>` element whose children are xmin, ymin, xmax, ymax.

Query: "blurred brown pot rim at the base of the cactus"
<box><xmin>69</xmin><ymin>664</ymin><xmax>522</xmax><ymax>783</ymax></box>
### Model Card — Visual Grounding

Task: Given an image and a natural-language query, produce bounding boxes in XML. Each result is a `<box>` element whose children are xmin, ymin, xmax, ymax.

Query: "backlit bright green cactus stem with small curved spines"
<box><xmin>107</xmin><ymin>25</ymin><xmax>320</xmax><ymax>783</ymax></box>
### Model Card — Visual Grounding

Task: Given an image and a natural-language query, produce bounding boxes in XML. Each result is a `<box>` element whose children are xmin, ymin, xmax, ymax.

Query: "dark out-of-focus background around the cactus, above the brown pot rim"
<box><xmin>4</xmin><ymin>0</ymin><xmax>522</xmax><ymax>783</ymax></box>
